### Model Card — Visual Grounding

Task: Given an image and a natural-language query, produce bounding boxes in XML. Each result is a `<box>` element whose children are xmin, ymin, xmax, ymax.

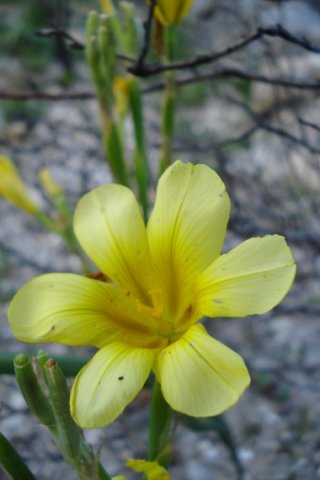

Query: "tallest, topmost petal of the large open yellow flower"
<box><xmin>148</xmin><ymin>161</ymin><xmax>230</xmax><ymax>322</ymax></box>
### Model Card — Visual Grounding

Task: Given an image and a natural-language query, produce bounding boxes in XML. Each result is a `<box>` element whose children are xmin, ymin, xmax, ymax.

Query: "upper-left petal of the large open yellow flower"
<box><xmin>74</xmin><ymin>185</ymin><xmax>156</xmax><ymax>304</ymax></box>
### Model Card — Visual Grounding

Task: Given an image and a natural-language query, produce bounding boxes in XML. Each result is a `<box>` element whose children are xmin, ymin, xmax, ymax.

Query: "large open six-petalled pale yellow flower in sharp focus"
<box><xmin>9</xmin><ymin>161</ymin><xmax>295</xmax><ymax>428</ymax></box>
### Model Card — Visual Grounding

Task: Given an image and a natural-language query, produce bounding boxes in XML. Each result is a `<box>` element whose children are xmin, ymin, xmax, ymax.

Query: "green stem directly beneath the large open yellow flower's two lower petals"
<box><xmin>148</xmin><ymin>380</ymin><xmax>173</xmax><ymax>460</ymax></box>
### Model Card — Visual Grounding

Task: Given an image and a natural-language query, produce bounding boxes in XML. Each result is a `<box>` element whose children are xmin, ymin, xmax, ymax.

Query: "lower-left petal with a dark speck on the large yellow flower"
<box><xmin>70</xmin><ymin>342</ymin><xmax>155</xmax><ymax>428</ymax></box>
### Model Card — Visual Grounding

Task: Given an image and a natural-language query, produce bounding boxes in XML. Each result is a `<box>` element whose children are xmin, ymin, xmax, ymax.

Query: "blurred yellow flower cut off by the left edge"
<box><xmin>0</xmin><ymin>155</ymin><xmax>39</xmax><ymax>214</ymax></box>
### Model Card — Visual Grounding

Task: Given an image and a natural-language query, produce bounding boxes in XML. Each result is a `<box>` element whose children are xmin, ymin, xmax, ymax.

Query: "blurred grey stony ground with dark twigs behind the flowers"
<box><xmin>0</xmin><ymin>0</ymin><xmax>320</xmax><ymax>480</ymax></box>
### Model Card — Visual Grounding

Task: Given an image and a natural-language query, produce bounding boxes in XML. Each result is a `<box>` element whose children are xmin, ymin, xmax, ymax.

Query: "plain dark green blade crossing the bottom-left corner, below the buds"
<box><xmin>0</xmin><ymin>433</ymin><xmax>36</xmax><ymax>480</ymax></box>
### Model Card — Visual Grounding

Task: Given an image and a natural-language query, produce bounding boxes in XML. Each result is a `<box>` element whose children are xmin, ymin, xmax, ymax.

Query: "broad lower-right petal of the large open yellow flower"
<box><xmin>155</xmin><ymin>325</ymin><xmax>250</xmax><ymax>417</ymax></box>
